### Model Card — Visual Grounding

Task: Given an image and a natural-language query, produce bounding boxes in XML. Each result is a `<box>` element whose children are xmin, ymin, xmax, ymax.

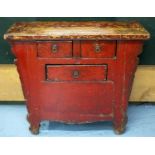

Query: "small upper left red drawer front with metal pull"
<box><xmin>38</xmin><ymin>41</ymin><xmax>72</xmax><ymax>58</ymax></box>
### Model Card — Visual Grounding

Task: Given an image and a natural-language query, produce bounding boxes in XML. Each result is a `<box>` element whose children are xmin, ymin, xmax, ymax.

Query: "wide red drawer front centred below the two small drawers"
<box><xmin>46</xmin><ymin>65</ymin><xmax>107</xmax><ymax>82</ymax></box>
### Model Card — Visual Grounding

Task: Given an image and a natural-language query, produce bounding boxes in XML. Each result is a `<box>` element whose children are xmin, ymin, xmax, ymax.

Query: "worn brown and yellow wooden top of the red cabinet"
<box><xmin>4</xmin><ymin>21</ymin><xmax>150</xmax><ymax>41</ymax></box>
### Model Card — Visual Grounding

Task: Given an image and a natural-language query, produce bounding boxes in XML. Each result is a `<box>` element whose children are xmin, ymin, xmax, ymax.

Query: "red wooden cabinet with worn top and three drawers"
<box><xmin>4</xmin><ymin>22</ymin><xmax>150</xmax><ymax>134</ymax></box>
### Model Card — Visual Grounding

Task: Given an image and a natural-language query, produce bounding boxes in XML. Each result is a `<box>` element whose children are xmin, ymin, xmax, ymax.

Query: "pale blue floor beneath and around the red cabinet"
<box><xmin>0</xmin><ymin>104</ymin><xmax>155</xmax><ymax>137</ymax></box>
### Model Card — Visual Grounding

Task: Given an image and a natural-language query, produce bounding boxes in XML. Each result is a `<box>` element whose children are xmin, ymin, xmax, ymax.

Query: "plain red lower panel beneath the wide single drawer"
<box><xmin>40</xmin><ymin>81</ymin><xmax>114</xmax><ymax>120</ymax></box>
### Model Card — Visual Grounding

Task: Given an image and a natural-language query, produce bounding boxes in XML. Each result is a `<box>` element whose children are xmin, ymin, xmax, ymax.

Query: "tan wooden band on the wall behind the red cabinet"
<box><xmin>0</xmin><ymin>64</ymin><xmax>155</xmax><ymax>102</ymax></box>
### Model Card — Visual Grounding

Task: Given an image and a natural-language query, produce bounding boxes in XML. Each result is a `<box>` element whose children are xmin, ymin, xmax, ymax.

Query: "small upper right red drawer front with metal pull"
<box><xmin>81</xmin><ymin>41</ymin><xmax>116</xmax><ymax>58</ymax></box>
